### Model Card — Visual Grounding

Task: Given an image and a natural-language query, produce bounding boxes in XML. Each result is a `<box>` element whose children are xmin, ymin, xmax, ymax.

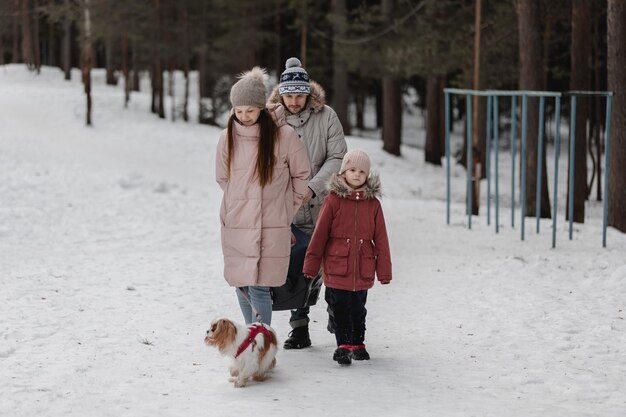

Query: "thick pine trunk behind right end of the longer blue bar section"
<box><xmin>516</xmin><ymin>0</ymin><xmax>551</xmax><ymax>218</ymax></box>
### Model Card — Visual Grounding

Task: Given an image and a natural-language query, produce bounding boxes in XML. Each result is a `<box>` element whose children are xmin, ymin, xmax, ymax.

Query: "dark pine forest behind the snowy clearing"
<box><xmin>0</xmin><ymin>0</ymin><xmax>626</xmax><ymax>232</ymax></box>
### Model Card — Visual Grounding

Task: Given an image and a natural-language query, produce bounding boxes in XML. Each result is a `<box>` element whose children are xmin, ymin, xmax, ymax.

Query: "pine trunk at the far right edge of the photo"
<box><xmin>605</xmin><ymin>0</ymin><xmax>626</xmax><ymax>232</ymax></box>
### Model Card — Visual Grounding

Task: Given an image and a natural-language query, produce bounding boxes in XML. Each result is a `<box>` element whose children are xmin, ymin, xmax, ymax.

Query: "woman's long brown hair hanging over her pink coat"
<box><xmin>226</xmin><ymin>109</ymin><xmax>278</xmax><ymax>187</ymax></box>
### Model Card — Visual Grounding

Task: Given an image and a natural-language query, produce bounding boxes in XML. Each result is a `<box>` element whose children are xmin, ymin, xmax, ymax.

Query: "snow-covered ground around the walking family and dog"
<box><xmin>0</xmin><ymin>66</ymin><xmax>626</xmax><ymax>417</ymax></box>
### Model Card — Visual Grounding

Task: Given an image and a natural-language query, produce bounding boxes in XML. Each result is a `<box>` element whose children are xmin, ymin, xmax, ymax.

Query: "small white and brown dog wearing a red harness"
<box><xmin>204</xmin><ymin>318</ymin><xmax>278</xmax><ymax>388</ymax></box>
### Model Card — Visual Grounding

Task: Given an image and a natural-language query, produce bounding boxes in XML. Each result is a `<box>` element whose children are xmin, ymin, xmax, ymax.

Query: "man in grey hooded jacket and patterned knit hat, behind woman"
<box><xmin>269</xmin><ymin>58</ymin><xmax>347</xmax><ymax>349</ymax></box>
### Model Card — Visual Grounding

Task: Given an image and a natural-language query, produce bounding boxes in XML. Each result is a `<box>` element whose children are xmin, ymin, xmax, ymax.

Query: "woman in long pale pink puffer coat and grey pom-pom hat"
<box><xmin>215</xmin><ymin>67</ymin><xmax>310</xmax><ymax>324</ymax></box>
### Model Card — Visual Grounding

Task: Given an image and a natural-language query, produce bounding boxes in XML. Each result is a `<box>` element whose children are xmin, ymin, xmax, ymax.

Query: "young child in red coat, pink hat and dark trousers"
<box><xmin>303</xmin><ymin>149</ymin><xmax>391</xmax><ymax>365</ymax></box>
